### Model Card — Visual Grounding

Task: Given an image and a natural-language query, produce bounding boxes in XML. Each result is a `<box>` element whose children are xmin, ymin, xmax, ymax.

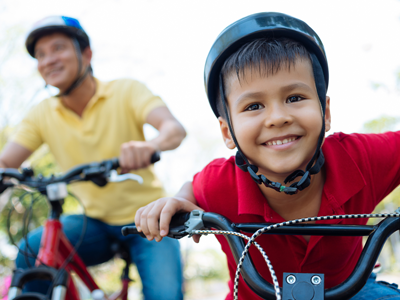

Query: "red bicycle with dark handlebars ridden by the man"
<box><xmin>0</xmin><ymin>152</ymin><xmax>160</xmax><ymax>300</ymax></box>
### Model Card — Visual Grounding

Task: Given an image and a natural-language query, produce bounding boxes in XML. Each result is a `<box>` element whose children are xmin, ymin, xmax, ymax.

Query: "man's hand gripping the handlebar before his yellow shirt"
<box><xmin>119</xmin><ymin>141</ymin><xmax>159</xmax><ymax>174</ymax></box>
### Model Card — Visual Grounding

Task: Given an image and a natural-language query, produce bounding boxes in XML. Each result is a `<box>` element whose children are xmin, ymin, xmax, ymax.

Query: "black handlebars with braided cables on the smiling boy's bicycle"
<box><xmin>122</xmin><ymin>208</ymin><xmax>400</xmax><ymax>300</ymax></box>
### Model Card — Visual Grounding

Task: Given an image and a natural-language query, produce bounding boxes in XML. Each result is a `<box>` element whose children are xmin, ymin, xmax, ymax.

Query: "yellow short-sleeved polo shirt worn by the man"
<box><xmin>12</xmin><ymin>79</ymin><xmax>165</xmax><ymax>225</ymax></box>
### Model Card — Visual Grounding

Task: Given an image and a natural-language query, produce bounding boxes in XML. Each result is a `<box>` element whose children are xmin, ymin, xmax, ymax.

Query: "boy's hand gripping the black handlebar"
<box><xmin>135</xmin><ymin>196</ymin><xmax>203</xmax><ymax>243</ymax></box>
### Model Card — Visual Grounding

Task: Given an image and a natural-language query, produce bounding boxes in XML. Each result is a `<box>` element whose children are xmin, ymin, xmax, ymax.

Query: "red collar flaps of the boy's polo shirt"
<box><xmin>235</xmin><ymin>136</ymin><xmax>366</xmax><ymax>221</ymax></box>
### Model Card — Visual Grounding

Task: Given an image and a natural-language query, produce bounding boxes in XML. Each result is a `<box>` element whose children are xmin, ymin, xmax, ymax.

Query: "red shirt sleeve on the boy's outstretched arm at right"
<box><xmin>340</xmin><ymin>131</ymin><xmax>400</xmax><ymax>205</ymax></box>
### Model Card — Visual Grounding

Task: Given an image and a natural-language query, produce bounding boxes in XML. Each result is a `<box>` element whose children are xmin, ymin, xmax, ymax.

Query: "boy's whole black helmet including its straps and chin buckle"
<box><xmin>204</xmin><ymin>12</ymin><xmax>329</xmax><ymax>195</ymax></box>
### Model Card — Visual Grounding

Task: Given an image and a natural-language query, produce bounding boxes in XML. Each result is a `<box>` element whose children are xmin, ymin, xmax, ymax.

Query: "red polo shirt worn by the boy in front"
<box><xmin>193</xmin><ymin>132</ymin><xmax>400</xmax><ymax>300</ymax></box>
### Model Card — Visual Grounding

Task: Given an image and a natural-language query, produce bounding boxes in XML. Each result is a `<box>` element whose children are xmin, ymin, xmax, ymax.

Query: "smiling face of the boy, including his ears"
<box><xmin>219</xmin><ymin>59</ymin><xmax>331</xmax><ymax>177</ymax></box>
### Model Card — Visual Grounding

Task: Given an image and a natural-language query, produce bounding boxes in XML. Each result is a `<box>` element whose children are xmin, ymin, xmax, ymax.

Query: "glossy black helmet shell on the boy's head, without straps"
<box><xmin>204</xmin><ymin>12</ymin><xmax>329</xmax><ymax>117</ymax></box>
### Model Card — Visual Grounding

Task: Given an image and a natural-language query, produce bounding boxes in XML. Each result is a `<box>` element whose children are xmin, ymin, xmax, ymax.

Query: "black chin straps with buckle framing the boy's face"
<box><xmin>219</xmin><ymin>53</ymin><xmax>326</xmax><ymax>195</ymax></box>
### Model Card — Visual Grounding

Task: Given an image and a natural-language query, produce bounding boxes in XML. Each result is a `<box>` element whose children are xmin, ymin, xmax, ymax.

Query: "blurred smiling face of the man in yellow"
<box><xmin>35</xmin><ymin>33</ymin><xmax>83</xmax><ymax>91</ymax></box>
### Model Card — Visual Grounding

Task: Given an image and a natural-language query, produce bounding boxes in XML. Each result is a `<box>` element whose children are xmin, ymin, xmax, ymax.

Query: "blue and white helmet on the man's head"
<box><xmin>25</xmin><ymin>16</ymin><xmax>90</xmax><ymax>57</ymax></box>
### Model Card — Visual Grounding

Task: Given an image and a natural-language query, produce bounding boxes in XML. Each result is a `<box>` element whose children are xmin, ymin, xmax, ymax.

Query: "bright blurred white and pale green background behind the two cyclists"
<box><xmin>0</xmin><ymin>0</ymin><xmax>400</xmax><ymax>300</ymax></box>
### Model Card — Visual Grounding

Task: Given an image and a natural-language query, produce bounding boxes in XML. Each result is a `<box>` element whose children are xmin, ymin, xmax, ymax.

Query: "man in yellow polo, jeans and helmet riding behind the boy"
<box><xmin>0</xmin><ymin>17</ymin><xmax>186</xmax><ymax>299</ymax></box>
